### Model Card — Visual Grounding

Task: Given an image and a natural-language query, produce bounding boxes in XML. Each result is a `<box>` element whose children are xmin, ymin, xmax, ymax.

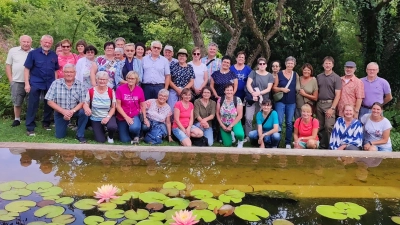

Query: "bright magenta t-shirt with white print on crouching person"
<box><xmin>115</xmin><ymin>84</ymin><xmax>144</xmax><ymax>121</ymax></box>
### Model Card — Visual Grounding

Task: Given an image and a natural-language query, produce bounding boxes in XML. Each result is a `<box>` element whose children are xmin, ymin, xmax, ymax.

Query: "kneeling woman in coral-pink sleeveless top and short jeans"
<box><xmin>172</xmin><ymin>88</ymin><xmax>203</xmax><ymax>146</ymax></box>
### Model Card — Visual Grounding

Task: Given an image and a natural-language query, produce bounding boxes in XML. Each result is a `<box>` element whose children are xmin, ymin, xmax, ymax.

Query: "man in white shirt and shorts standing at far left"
<box><xmin>6</xmin><ymin>35</ymin><xmax>32</xmax><ymax>127</ymax></box>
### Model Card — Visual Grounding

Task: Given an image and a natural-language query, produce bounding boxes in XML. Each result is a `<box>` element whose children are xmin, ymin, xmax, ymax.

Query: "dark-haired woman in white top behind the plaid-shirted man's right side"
<box><xmin>76</xmin><ymin>45</ymin><xmax>97</xmax><ymax>90</ymax></box>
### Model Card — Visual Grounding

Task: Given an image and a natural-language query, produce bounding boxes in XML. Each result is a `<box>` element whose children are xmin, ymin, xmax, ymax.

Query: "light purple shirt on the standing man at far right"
<box><xmin>360</xmin><ymin>77</ymin><xmax>391</xmax><ymax>107</ymax></box>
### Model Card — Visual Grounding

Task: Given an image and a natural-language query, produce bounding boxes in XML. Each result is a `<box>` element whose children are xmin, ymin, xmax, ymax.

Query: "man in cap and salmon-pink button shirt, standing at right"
<box><xmin>338</xmin><ymin>61</ymin><xmax>365</xmax><ymax>118</ymax></box>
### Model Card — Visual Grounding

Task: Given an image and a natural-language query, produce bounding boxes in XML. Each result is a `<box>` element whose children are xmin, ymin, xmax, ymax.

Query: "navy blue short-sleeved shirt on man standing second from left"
<box><xmin>24</xmin><ymin>48</ymin><xmax>59</xmax><ymax>90</ymax></box>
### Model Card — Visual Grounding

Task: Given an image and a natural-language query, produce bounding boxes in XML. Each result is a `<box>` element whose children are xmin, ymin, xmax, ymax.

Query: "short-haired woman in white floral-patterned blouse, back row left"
<box><xmin>91</xmin><ymin>42</ymin><xmax>121</xmax><ymax>90</ymax></box>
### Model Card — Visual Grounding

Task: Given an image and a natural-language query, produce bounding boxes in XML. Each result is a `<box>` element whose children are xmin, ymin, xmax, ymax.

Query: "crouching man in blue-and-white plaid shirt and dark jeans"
<box><xmin>45</xmin><ymin>63</ymin><xmax>89</xmax><ymax>143</ymax></box>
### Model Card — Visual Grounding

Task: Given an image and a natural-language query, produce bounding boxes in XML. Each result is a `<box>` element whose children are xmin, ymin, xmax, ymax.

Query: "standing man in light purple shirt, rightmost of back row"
<box><xmin>359</xmin><ymin>62</ymin><xmax>393</xmax><ymax>118</ymax></box>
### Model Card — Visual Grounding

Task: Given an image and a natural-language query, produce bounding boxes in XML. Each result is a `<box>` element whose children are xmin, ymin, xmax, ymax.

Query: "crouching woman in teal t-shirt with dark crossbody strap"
<box><xmin>249</xmin><ymin>99</ymin><xmax>281</xmax><ymax>148</ymax></box>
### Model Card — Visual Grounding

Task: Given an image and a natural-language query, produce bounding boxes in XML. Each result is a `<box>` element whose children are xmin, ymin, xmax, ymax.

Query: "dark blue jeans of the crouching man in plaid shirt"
<box><xmin>54</xmin><ymin>109</ymin><xmax>89</xmax><ymax>138</ymax></box>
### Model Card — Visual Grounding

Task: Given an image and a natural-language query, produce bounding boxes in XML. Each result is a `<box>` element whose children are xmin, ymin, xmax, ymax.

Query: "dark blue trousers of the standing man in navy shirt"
<box><xmin>25</xmin><ymin>85</ymin><xmax>53</xmax><ymax>131</ymax></box>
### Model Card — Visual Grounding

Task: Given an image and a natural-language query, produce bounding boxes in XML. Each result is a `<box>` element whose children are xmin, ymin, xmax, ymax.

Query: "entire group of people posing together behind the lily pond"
<box><xmin>6</xmin><ymin>35</ymin><xmax>392</xmax><ymax>151</ymax></box>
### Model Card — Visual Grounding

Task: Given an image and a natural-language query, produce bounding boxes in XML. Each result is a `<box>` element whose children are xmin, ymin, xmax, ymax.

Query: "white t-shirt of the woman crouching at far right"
<box><xmin>361</xmin><ymin>114</ymin><xmax>392</xmax><ymax>149</ymax></box>
